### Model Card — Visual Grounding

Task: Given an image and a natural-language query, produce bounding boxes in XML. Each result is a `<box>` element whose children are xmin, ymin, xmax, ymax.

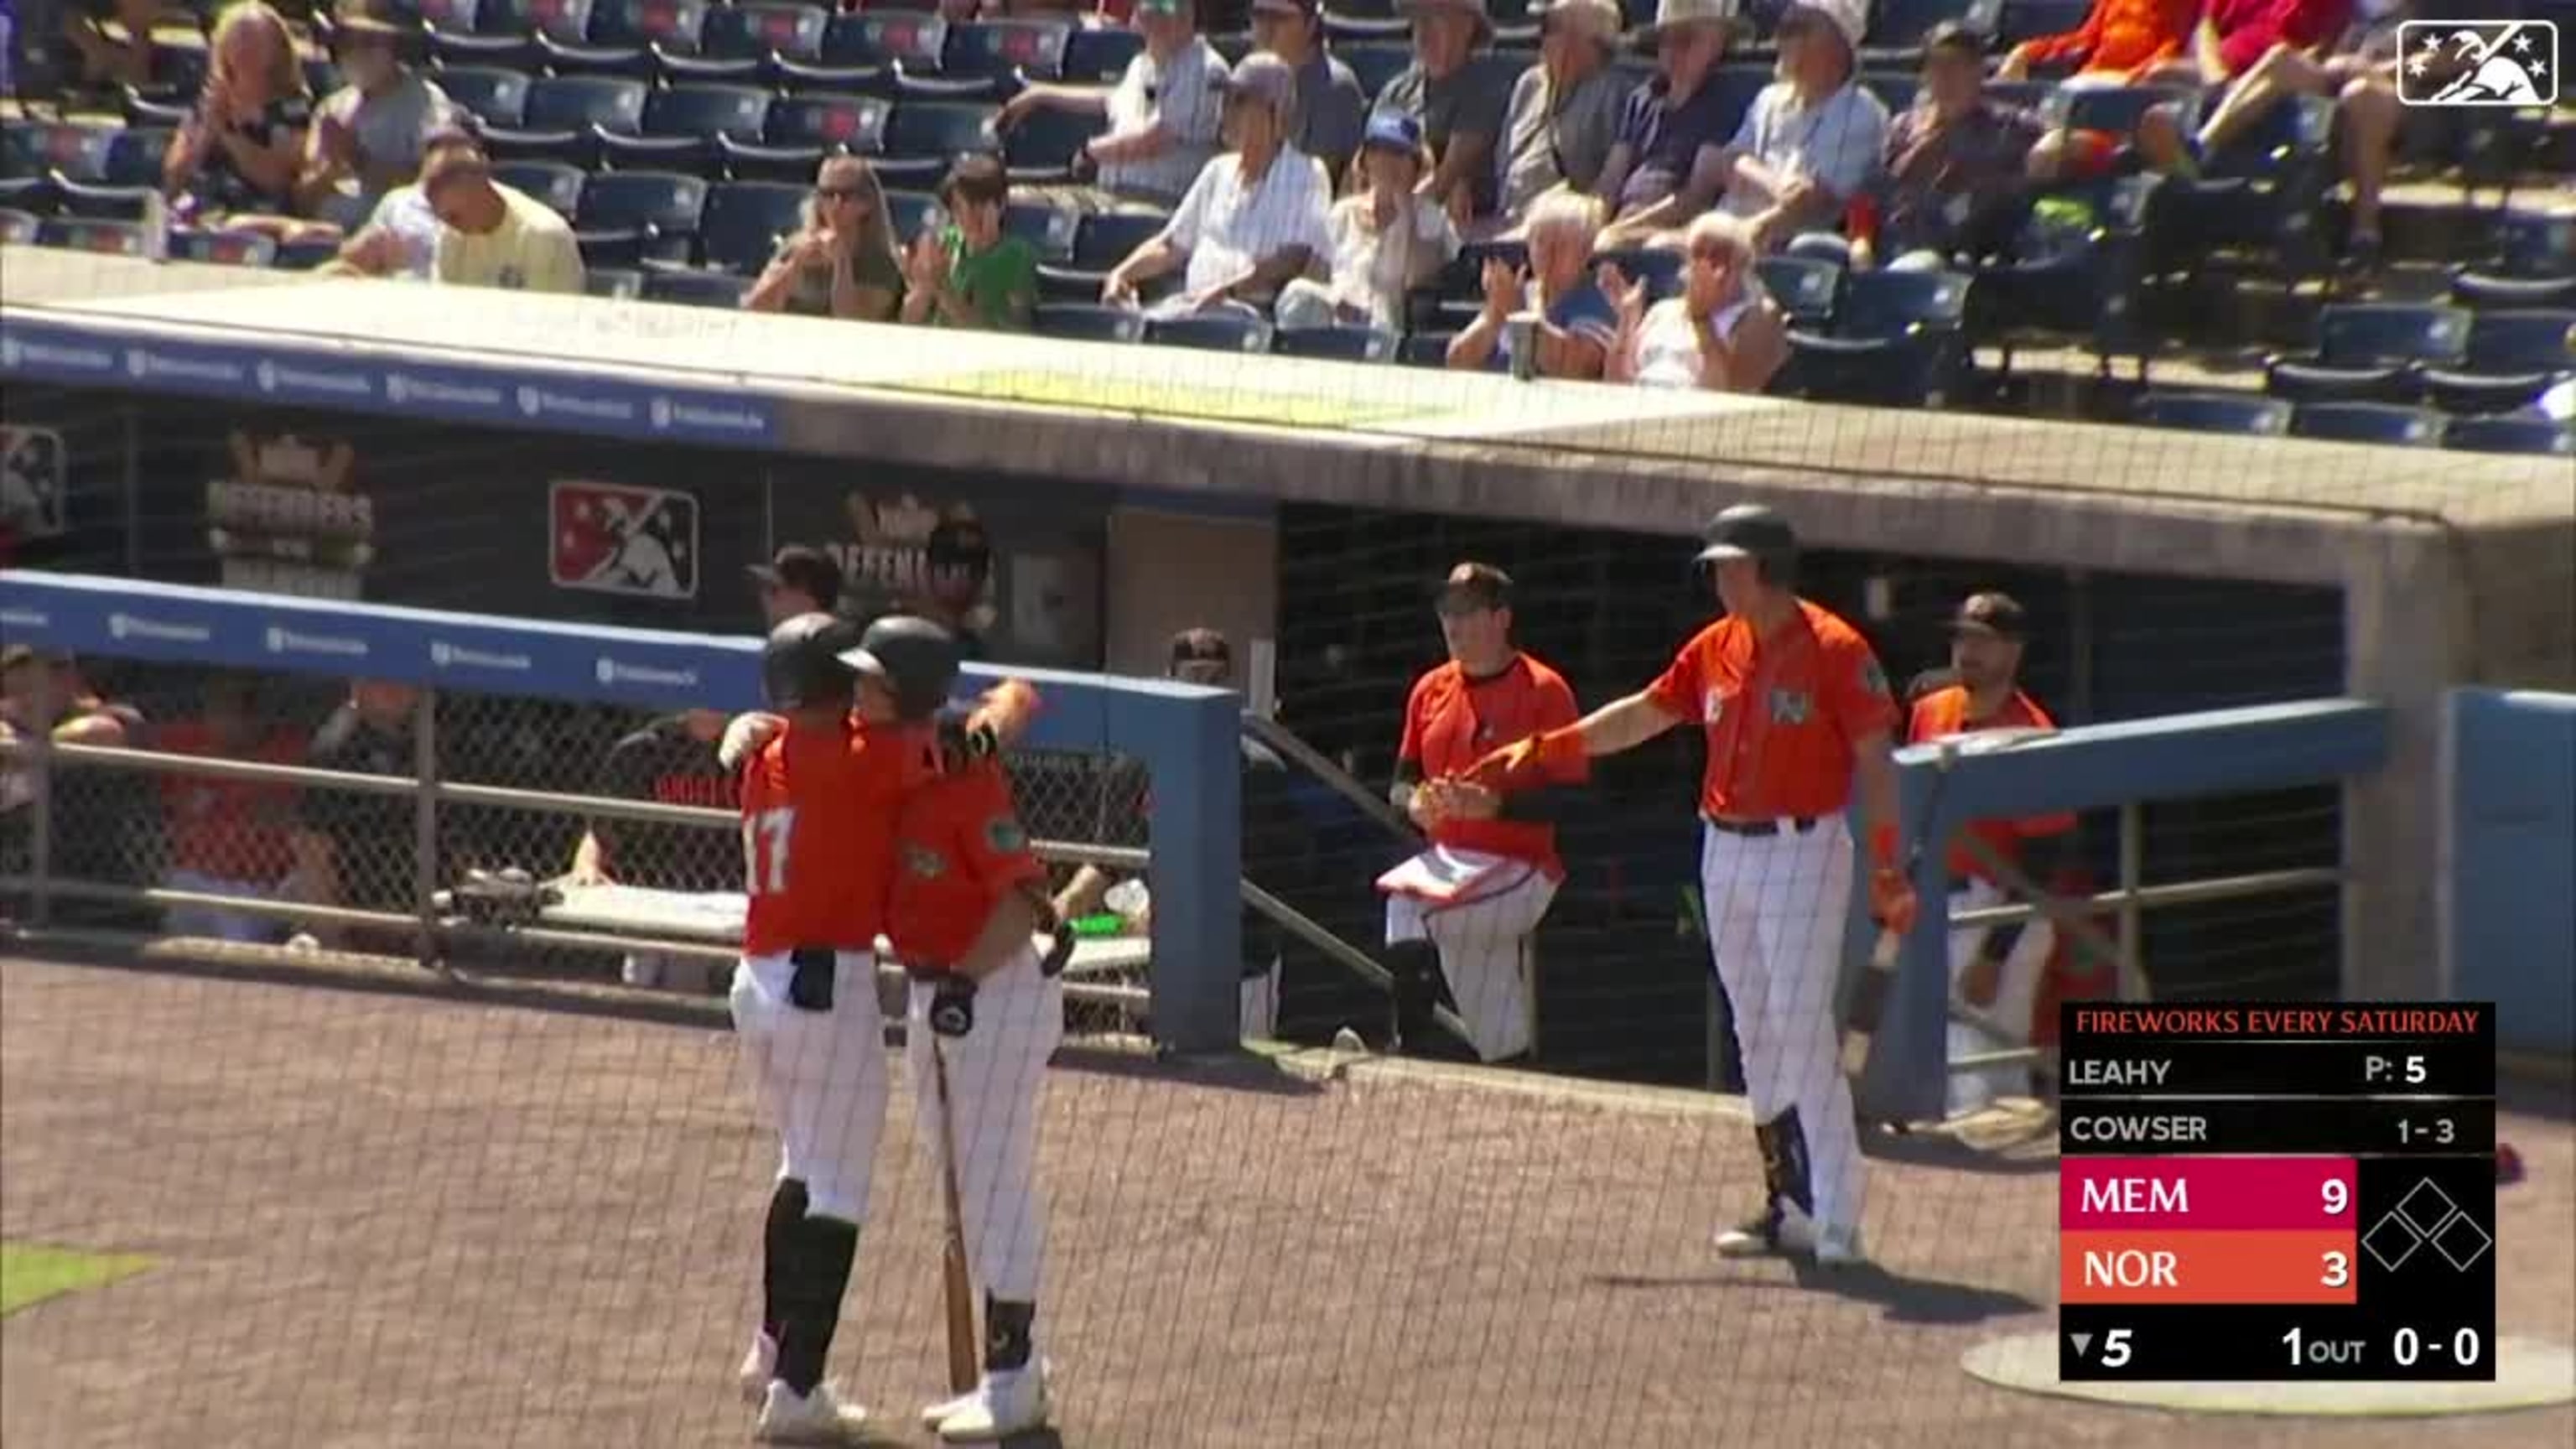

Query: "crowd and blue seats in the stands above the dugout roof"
<box><xmin>0</xmin><ymin>0</ymin><xmax>2576</xmax><ymax>451</ymax></box>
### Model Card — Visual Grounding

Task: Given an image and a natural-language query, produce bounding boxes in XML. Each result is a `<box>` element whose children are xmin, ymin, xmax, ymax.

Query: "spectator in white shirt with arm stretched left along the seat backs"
<box><xmin>1000</xmin><ymin>0</ymin><xmax>1226</xmax><ymax>206</ymax></box>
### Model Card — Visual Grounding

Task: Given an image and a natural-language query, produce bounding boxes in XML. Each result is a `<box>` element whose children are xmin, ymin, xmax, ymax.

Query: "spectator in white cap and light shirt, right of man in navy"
<box><xmin>1718</xmin><ymin>0</ymin><xmax>1888</xmax><ymax>252</ymax></box>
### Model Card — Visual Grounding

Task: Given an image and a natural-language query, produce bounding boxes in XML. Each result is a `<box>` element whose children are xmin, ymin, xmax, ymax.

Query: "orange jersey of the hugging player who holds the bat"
<box><xmin>886</xmin><ymin>761</ymin><xmax>1046</xmax><ymax>967</ymax></box>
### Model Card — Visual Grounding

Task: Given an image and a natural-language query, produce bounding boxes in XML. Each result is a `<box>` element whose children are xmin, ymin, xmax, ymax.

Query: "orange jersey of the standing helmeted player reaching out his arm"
<box><xmin>1646</xmin><ymin>598</ymin><xmax>1896</xmax><ymax>820</ymax></box>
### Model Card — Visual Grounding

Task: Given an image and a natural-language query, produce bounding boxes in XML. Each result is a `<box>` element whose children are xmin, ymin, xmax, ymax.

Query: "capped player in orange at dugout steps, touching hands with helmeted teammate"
<box><xmin>1379</xmin><ymin>564</ymin><xmax>1589</xmax><ymax>1062</ymax></box>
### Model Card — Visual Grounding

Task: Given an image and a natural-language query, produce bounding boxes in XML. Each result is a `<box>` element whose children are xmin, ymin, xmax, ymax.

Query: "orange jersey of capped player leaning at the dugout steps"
<box><xmin>1396</xmin><ymin>655</ymin><xmax>1587</xmax><ymax>879</ymax></box>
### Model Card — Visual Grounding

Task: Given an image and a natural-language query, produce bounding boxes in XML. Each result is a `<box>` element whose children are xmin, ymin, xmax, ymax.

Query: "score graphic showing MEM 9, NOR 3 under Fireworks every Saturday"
<box><xmin>2059</xmin><ymin>1003</ymin><xmax>2496</xmax><ymax>1382</ymax></box>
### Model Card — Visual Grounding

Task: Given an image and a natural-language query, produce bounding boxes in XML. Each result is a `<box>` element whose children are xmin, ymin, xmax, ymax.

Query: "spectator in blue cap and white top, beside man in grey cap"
<box><xmin>1278</xmin><ymin>111</ymin><xmax>1458</xmax><ymax>333</ymax></box>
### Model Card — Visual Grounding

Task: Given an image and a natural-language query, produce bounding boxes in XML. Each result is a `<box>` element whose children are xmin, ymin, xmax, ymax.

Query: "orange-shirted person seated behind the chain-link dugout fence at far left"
<box><xmin>157</xmin><ymin>676</ymin><xmax>304</xmax><ymax>943</ymax></box>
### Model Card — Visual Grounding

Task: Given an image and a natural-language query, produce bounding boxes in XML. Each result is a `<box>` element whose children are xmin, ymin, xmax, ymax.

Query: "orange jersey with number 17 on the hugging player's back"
<box><xmin>742</xmin><ymin>719</ymin><xmax>927</xmax><ymax>957</ymax></box>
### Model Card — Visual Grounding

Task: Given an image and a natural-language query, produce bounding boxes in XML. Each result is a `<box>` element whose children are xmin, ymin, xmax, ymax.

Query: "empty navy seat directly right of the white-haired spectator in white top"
<box><xmin>1773</xmin><ymin>271</ymin><xmax>1971</xmax><ymax>408</ymax></box>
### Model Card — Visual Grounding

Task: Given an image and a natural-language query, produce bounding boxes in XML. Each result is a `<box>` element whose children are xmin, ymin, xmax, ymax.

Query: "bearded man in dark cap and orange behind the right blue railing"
<box><xmin>1906</xmin><ymin>593</ymin><xmax>2076</xmax><ymax>1111</ymax></box>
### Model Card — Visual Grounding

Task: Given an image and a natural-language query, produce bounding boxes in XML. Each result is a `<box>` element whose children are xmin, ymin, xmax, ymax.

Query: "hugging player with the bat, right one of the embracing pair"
<box><xmin>865</xmin><ymin>616</ymin><xmax>1072</xmax><ymax>1444</ymax></box>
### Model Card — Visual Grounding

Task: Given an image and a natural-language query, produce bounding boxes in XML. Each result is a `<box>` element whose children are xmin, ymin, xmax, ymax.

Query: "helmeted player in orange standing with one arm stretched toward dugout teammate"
<box><xmin>1476</xmin><ymin>506</ymin><xmax>1914</xmax><ymax>1266</ymax></box>
